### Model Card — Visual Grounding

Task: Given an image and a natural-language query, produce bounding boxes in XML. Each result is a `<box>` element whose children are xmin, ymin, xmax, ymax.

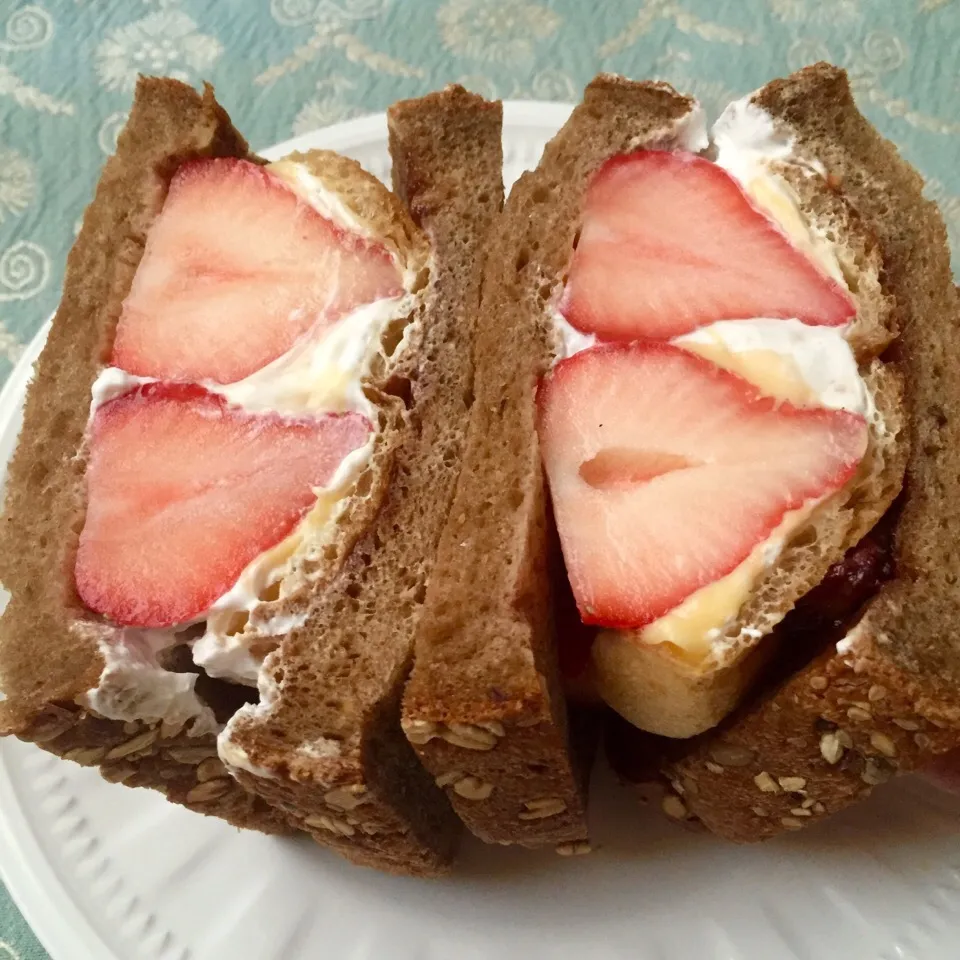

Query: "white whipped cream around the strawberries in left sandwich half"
<box><xmin>86</xmin><ymin>160</ymin><xmax>420</xmax><ymax>720</ymax></box>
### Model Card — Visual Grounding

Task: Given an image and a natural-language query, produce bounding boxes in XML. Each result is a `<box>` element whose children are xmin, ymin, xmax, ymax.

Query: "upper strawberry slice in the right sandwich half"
<box><xmin>560</xmin><ymin>150</ymin><xmax>856</xmax><ymax>340</ymax></box>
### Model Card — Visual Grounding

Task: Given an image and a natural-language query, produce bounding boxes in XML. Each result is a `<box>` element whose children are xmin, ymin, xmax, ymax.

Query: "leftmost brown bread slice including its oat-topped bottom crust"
<box><xmin>0</xmin><ymin>78</ymin><xmax>289</xmax><ymax>832</ymax></box>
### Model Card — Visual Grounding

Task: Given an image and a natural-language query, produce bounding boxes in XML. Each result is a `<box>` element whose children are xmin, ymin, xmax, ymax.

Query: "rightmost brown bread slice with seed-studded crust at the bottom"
<box><xmin>666</xmin><ymin>64</ymin><xmax>960</xmax><ymax>841</ymax></box>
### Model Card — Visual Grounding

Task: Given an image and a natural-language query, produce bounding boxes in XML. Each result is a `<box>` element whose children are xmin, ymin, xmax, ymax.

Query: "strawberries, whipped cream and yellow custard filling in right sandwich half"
<box><xmin>538</xmin><ymin>100</ymin><xmax>876</xmax><ymax>668</ymax></box>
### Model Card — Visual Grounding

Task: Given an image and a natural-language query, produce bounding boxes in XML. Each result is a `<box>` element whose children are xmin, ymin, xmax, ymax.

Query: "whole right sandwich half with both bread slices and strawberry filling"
<box><xmin>403</xmin><ymin>64</ymin><xmax>960</xmax><ymax>853</ymax></box>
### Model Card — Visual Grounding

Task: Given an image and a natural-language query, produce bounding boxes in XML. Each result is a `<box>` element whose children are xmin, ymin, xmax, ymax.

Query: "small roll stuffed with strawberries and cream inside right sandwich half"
<box><xmin>538</xmin><ymin>71</ymin><xmax>907</xmax><ymax>738</ymax></box>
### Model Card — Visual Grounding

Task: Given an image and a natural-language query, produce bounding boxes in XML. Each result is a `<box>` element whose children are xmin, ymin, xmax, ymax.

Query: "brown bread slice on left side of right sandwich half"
<box><xmin>404</xmin><ymin>76</ymin><xmax>693</xmax><ymax>846</ymax></box>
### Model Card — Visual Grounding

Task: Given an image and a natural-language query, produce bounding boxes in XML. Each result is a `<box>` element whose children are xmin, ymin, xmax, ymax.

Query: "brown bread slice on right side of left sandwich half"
<box><xmin>221</xmin><ymin>86</ymin><xmax>503</xmax><ymax>876</ymax></box>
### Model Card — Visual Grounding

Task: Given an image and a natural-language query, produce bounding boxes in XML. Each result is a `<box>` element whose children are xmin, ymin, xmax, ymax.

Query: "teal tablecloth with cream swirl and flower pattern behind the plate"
<box><xmin>0</xmin><ymin>0</ymin><xmax>960</xmax><ymax>960</ymax></box>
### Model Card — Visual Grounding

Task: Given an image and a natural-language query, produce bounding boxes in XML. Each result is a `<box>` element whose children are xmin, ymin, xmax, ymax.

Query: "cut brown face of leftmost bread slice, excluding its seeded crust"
<box><xmin>0</xmin><ymin>79</ymin><xmax>248</xmax><ymax>733</ymax></box>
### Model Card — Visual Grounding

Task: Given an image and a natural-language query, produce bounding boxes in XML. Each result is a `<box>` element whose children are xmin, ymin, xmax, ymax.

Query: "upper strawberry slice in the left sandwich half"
<box><xmin>112</xmin><ymin>158</ymin><xmax>403</xmax><ymax>383</ymax></box>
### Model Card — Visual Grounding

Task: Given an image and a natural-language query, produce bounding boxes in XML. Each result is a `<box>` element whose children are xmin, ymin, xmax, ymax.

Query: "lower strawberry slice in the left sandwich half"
<box><xmin>76</xmin><ymin>383</ymin><xmax>370</xmax><ymax>627</ymax></box>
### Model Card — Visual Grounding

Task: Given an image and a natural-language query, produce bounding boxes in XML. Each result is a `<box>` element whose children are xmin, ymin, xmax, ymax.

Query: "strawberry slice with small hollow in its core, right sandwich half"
<box><xmin>538</xmin><ymin>341</ymin><xmax>867</xmax><ymax>628</ymax></box>
